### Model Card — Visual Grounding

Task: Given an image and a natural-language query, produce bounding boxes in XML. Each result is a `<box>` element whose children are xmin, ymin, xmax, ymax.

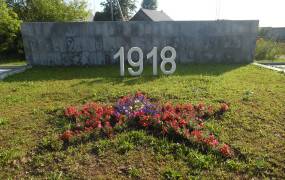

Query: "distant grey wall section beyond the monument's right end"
<box><xmin>260</xmin><ymin>27</ymin><xmax>285</xmax><ymax>41</ymax></box>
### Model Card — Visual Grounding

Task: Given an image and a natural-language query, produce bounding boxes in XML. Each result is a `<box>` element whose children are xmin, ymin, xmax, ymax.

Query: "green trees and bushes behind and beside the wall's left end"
<box><xmin>0</xmin><ymin>0</ymin><xmax>91</xmax><ymax>55</ymax></box>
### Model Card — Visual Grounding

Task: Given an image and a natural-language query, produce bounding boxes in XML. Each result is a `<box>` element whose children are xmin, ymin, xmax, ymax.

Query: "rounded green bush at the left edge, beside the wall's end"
<box><xmin>0</xmin><ymin>0</ymin><xmax>21</xmax><ymax>53</ymax></box>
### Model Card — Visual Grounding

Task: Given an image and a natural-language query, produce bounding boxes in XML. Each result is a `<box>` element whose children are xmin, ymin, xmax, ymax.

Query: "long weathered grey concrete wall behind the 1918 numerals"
<box><xmin>21</xmin><ymin>21</ymin><xmax>258</xmax><ymax>66</ymax></box>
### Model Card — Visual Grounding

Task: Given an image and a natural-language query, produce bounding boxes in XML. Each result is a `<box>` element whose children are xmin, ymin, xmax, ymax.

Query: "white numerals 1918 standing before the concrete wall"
<box><xmin>114</xmin><ymin>46</ymin><xmax>176</xmax><ymax>76</ymax></box>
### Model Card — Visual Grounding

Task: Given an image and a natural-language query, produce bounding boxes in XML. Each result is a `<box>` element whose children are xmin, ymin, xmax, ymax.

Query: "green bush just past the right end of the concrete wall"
<box><xmin>255</xmin><ymin>39</ymin><xmax>280</xmax><ymax>60</ymax></box>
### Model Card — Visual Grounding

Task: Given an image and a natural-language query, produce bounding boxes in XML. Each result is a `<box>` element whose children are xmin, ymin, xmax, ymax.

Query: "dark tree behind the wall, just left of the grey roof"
<box><xmin>94</xmin><ymin>0</ymin><xmax>137</xmax><ymax>21</ymax></box>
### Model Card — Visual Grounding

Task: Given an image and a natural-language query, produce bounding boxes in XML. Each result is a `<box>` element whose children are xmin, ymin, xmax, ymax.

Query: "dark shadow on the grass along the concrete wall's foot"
<box><xmin>4</xmin><ymin>64</ymin><xmax>247</xmax><ymax>85</ymax></box>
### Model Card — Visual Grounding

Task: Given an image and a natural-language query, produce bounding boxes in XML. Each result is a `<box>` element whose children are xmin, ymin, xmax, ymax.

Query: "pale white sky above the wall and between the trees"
<box><xmin>88</xmin><ymin>0</ymin><xmax>285</xmax><ymax>27</ymax></box>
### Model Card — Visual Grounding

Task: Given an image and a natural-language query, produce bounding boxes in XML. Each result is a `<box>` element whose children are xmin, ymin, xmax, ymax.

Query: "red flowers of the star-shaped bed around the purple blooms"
<box><xmin>60</xmin><ymin>92</ymin><xmax>233</xmax><ymax>157</ymax></box>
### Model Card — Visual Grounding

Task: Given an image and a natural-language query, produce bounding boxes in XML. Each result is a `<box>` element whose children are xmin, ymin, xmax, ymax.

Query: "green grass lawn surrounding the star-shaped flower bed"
<box><xmin>0</xmin><ymin>65</ymin><xmax>285</xmax><ymax>179</ymax></box>
